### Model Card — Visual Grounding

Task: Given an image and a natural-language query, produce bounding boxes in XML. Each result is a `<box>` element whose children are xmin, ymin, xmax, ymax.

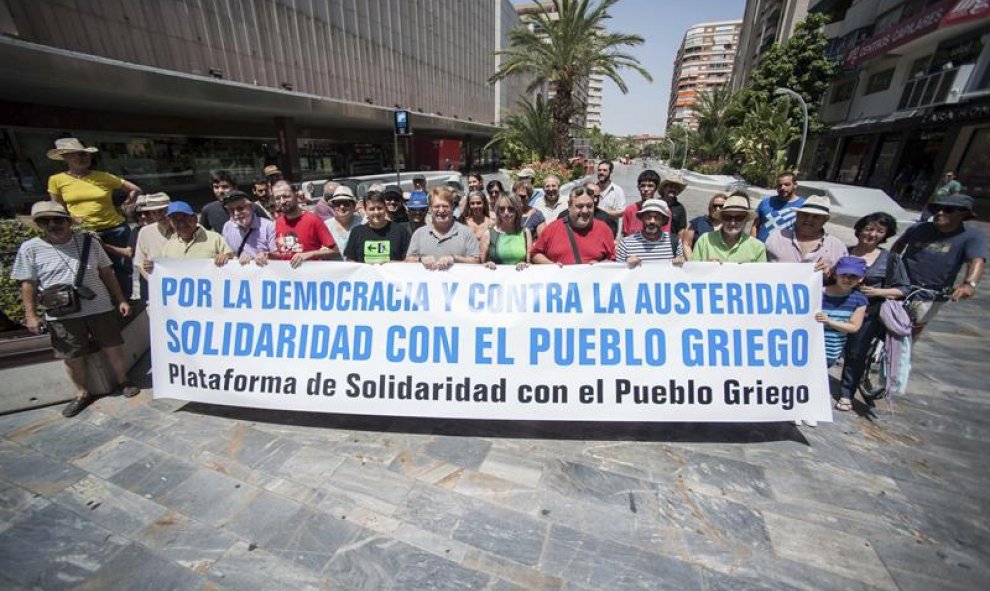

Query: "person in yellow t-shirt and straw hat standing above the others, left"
<box><xmin>48</xmin><ymin>138</ymin><xmax>141</xmax><ymax>297</ymax></box>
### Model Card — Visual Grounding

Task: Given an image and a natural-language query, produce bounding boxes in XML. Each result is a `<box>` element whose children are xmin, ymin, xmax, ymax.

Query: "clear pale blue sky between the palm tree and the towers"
<box><xmin>515</xmin><ymin>0</ymin><xmax>746</xmax><ymax>135</ymax></box>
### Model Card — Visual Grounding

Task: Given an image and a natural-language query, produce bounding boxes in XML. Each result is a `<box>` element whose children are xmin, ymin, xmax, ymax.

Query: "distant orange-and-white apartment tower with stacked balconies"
<box><xmin>667</xmin><ymin>20</ymin><xmax>742</xmax><ymax>129</ymax></box>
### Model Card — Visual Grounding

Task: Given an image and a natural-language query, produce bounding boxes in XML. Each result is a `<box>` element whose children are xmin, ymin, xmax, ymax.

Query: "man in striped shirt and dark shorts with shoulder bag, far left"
<box><xmin>10</xmin><ymin>200</ymin><xmax>140</xmax><ymax>417</ymax></box>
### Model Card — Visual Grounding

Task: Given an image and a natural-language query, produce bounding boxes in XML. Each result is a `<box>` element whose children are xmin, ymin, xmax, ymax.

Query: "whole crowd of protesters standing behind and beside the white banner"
<box><xmin>11</xmin><ymin>138</ymin><xmax>986</xmax><ymax>425</ymax></box>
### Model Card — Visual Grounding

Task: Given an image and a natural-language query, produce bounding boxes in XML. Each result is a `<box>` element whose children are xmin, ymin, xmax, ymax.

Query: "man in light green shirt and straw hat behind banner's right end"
<box><xmin>691</xmin><ymin>195</ymin><xmax>767</xmax><ymax>263</ymax></box>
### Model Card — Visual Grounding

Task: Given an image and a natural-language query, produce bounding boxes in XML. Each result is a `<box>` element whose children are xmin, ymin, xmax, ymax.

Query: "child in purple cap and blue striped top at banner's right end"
<box><xmin>815</xmin><ymin>256</ymin><xmax>869</xmax><ymax>367</ymax></box>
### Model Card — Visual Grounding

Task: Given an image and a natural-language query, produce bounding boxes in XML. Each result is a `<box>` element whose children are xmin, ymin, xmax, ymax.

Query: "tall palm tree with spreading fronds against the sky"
<box><xmin>489</xmin><ymin>0</ymin><xmax>653</xmax><ymax>159</ymax></box>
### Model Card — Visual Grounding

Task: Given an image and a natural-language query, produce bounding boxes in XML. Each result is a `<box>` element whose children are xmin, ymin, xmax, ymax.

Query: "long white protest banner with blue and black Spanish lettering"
<box><xmin>150</xmin><ymin>260</ymin><xmax>831</xmax><ymax>422</ymax></box>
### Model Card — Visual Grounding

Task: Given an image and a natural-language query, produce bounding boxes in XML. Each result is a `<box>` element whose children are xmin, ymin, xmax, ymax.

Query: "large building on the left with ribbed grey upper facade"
<box><xmin>0</xmin><ymin>0</ymin><xmax>524</xmax><ymax>210</ymax></box>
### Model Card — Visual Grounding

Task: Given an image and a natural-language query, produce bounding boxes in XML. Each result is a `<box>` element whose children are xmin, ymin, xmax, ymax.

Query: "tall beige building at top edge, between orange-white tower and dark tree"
<box><xmin>732</xmin><ymin>0</ymin><xmax>812</xmax><ymax>90</ymax></box>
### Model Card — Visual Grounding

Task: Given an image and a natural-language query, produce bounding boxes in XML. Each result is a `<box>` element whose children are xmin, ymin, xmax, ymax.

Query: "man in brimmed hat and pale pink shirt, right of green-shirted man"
<box><xmin>766</xmin><ymin>195</ymin><xmax>849</xmax><ymax>277</ymax></box>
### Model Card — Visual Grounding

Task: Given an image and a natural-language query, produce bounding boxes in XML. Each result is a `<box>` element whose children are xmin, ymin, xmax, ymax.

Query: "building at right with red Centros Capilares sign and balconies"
<box><xmin>802</xmin><ymin>0</ymin><xmax>990</xmax><ymax>202</ymax></box>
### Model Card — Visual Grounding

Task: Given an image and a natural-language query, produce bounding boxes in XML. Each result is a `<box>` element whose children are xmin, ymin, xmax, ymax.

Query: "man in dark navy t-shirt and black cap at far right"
<box><xmin>891</xmin><ymin>193</ymin><xmax>987</xmax><ymax>338</ymax></box>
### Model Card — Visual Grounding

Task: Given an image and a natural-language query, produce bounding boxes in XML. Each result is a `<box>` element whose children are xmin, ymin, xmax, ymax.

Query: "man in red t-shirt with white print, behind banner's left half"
<box><xmin>255</xmin><ymin>181</ymin><xmax>340</xmax><ymax>268</ymax></box>
